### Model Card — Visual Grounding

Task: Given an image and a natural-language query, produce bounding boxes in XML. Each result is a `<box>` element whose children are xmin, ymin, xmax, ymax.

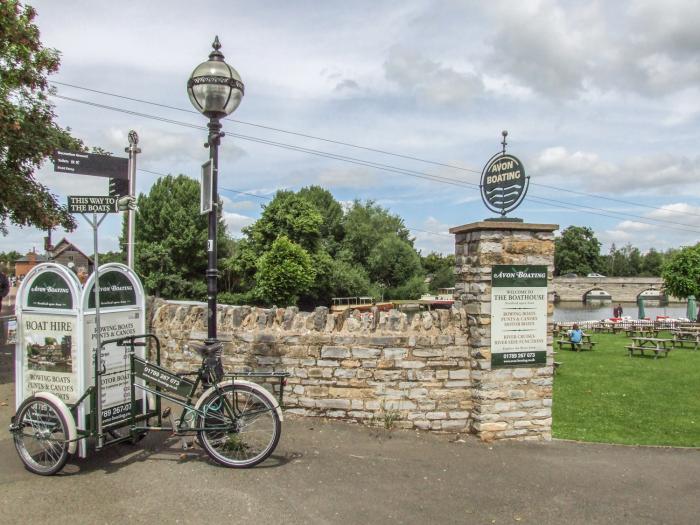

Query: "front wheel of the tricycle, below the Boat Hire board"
<box><xmin>14</xmin><ymin>397</ymin><xmax>69</xmax><ymax>476</ymax></box>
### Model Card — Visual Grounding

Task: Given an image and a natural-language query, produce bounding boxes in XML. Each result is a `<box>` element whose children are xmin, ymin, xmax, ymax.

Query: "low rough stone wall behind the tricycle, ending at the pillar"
<box><xmin>151</xmin><ymin>301</ymin><xmax>472</xmax><ymax>432</ymax></box>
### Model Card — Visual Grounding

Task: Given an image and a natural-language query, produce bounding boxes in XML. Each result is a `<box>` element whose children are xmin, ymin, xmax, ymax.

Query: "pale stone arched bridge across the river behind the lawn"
<box><xmin>552</xmin><ymin>277</ymin><xmax>678</xmax><ymax>302</ymax></box>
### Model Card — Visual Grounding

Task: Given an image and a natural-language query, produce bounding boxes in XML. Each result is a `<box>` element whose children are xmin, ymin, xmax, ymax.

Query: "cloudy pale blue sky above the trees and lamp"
<box><xmin>0</xmin><ymin>0</ymin><xmax>700</xmax><ymax>254</ymax></box>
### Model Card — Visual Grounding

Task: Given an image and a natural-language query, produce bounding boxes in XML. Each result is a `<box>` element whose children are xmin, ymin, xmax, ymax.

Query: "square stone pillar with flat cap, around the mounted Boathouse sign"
<box><xmin>450</xmin><ymin>221</ymin><xmax>559</xmax><ymax>441</ymax></box>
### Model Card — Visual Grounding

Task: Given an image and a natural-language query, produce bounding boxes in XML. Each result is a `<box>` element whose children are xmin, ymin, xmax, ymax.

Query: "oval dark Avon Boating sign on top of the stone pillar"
<box><xmin>480</xmin><ymin>153</ymin><xmax>529</xmax><ymax>215</ymax></box>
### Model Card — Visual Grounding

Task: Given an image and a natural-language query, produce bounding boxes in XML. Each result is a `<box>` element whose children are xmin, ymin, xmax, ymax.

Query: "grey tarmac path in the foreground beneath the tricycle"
<box><xmin>0</xmin><ymin>348</ymin><xmax>700</xmax><ymax>525</ymax></box>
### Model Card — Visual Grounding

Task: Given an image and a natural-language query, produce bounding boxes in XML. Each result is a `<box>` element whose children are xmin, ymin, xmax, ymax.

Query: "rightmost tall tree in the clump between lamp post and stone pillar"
<box><xmin>342</xmin><ymin>200</ymin><xmax>413</xmax><ymax>266</ymax></box>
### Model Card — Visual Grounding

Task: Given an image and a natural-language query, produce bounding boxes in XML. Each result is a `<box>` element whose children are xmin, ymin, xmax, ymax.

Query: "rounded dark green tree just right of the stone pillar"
<box><xmin>554</xmin><ymin>226</ymin><xmax>602</xmax><ymax>275</ymax></box>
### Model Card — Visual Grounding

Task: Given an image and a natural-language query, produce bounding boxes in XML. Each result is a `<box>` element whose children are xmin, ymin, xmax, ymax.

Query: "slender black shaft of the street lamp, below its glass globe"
<box><xmin>206</xmin><ymin>117</ymin><xmax>223</xmax><ymax>344</ymax></box>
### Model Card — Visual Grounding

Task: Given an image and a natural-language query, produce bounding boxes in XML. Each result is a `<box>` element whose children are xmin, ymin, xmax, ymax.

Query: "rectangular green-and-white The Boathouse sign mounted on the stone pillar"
<box><xmin>491</xmin><ymin>265</ymin><xmax>547</xmax><ymax>367</ymax></box>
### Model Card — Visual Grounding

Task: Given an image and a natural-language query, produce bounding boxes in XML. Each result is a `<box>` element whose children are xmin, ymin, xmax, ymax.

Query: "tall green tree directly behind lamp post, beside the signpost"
<box><xmin>135</xmin><ymin>175</ymin><xmax>229</xmax><ymax>299</ymax></box>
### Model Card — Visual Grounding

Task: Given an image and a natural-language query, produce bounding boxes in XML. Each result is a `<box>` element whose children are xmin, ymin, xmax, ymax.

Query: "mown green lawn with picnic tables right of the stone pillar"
<box><xmin>552</xmin><ymin>333</ymin><xmax>700</xmax><ymax>447</ymax></box>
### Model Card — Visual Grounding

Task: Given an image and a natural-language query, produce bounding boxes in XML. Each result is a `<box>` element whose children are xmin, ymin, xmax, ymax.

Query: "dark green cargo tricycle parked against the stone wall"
<box><xmin>10</xmin><ymin>334</ymin><xmax>289</xmax><ymax>476</ymax></box>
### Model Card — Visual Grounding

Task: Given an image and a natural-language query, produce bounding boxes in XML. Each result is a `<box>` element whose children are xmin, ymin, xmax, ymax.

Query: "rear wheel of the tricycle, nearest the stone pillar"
<box><xmin>197</xmin><ymin>385</ymin><xmax>282</xmax><ymax>468</ymax></box>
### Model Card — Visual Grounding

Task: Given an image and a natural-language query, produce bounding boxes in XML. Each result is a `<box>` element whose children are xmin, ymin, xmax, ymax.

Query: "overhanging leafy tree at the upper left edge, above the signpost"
<box><xmin>0</xmin><ymin>0</ymin><xmax>83</xmax><ymax>235</ymax></box>
